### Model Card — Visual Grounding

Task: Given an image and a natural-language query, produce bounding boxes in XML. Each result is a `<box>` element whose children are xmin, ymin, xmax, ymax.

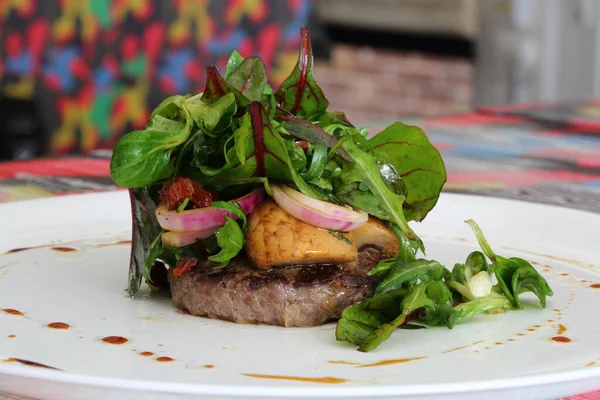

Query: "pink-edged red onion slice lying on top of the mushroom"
<box><xmin>271</xmin><ymin>185</ymin><xmax>369</xmax><ymax>232</ymax></box>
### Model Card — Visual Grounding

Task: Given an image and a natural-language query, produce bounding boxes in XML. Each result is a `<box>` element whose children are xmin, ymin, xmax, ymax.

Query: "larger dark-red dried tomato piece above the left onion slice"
<box><xmin>158</xmin><ymin>177</ymin><xmax>217</xmax><ymax>210</ymax></box>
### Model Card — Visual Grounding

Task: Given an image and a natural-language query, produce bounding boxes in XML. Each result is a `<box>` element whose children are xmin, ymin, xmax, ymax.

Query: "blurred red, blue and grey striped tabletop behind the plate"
<box><xmin>0</xmin><ymin>99</ymin><xmax>600</xmax><ymax>400</ymax></box>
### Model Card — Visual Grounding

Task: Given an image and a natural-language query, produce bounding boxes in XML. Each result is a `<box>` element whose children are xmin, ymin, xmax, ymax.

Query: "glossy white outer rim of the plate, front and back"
<box><xmin>0</xmin><ymin>190</ymin><xmax>600</xmax><ymax>398</ymax></box>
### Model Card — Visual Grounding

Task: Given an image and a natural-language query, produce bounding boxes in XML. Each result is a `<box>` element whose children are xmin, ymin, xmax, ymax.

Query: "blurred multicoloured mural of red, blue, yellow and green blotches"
<box><xmin>0</xmin><ymin>0</ymin><xmax>310</xmax><ymax>155</ymax></box>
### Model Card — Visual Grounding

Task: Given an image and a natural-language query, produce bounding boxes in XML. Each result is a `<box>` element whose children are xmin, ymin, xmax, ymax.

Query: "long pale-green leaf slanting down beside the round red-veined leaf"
<box><xmin>336</xmin><ymin>140</ymin><xmax>424</xmax><ymax>244</ymax></box>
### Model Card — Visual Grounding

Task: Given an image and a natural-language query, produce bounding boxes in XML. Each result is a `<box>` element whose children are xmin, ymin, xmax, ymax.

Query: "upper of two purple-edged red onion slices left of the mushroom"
<box><xmin>156</xmin><ymin>188</ymin><xmax>265</xmax><ymax>232</ymax></box>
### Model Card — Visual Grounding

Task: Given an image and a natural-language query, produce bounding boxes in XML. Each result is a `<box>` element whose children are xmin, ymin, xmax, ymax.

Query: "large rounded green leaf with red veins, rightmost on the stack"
<box><xmin>369</xmin><ymin>122</ymin><xmax>446</xmax><ymax>221</ymax></box>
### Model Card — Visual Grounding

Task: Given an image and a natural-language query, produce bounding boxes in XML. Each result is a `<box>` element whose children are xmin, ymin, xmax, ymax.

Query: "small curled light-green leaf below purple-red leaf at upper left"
<box><xmin>183</xmin><ymin>93</ymin><xmax>237</xmax><ymax>133</ymax></box>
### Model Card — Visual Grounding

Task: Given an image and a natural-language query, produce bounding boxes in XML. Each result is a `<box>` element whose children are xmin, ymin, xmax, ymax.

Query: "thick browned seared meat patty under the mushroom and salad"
<box><xmin>169</xmin><ymin>248</ymin><xmax>383</xmax><ymax>327</ymax></box>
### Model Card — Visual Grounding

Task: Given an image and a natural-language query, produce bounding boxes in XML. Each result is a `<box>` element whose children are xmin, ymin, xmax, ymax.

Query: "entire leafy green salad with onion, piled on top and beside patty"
<box><xmin>110</xmin><ymin>27</ymin><xmax>553</xmax><ymax>351</ymax></box>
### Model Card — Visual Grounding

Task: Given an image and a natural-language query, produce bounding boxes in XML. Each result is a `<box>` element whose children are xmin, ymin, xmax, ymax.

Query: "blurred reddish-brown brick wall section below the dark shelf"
<box><xmin>315</xmin><ymin>44</ymin><xmax>473</xmax><ymax>123</ymax></box>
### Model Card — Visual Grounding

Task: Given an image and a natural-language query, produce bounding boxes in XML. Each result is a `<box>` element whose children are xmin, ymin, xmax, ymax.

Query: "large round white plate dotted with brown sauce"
<box><xmin>0</xmin><ymin>192</ymin><xmax>600</xmax><ymax>400</ymax></box>
